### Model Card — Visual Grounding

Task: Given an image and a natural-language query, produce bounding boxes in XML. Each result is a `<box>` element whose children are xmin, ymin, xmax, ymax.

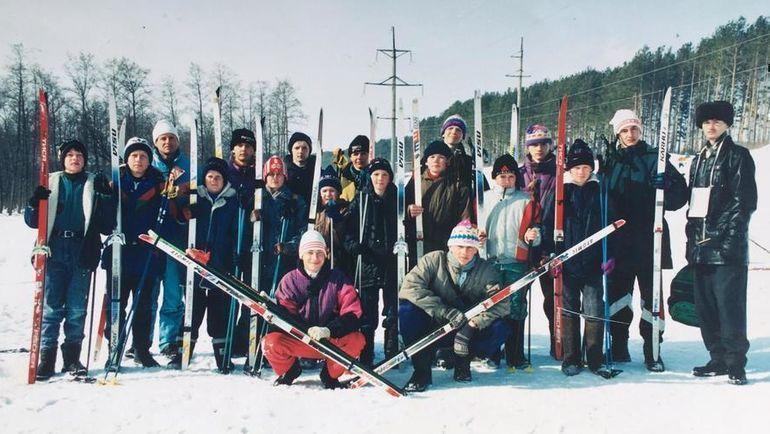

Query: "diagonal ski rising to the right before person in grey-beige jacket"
<box><xmin>351</xmin><ymin>219</ymin><xmax>626</xmax><ymax>388</ymax></box>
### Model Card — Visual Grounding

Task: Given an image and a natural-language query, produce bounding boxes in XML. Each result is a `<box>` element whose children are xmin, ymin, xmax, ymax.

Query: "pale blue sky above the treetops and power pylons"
<box><xmin>0</xmin><ymin>0</ymin><xmax>770</xmax><ymax>147</ymax></box>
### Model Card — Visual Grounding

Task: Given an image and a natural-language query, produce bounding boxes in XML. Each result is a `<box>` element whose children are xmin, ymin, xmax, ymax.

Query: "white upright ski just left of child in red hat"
<box><xmin>249</xmin><ymin>118</ymin><xmax>264</xmax><ymax>374</ymax></box>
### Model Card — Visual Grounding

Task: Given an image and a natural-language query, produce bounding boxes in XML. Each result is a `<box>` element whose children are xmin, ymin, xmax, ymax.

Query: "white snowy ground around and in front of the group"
<box><xmin>0</xmin><ymin>147</ymin><xmax>770</xmax><ymax>434</ymax></box>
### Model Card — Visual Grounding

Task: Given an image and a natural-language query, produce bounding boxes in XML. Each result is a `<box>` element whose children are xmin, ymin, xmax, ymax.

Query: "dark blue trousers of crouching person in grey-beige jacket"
<box><xmin>398</xmin><ymin>300</ymin><xmax>511</xmax><ymax>358</ymax></box>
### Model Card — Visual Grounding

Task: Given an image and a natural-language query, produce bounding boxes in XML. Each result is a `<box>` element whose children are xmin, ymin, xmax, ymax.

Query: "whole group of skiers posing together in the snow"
<box><xmin>25</xmin><ymin>101</ymin><xmax>757</xmax><ymax>392</ymax></box>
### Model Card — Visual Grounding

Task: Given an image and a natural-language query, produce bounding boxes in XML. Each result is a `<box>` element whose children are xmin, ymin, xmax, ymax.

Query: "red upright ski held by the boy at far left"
<box><xmin>27</xmin><ymin>88</ymin><xmax>51</xmax><ymax>384</ymax></box>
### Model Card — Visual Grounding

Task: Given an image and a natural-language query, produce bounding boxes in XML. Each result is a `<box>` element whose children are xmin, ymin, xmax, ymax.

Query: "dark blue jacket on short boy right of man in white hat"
<box><xmin>195</xmin><ymin>182</ymin><xmax>238</xmax><ymax>273</ymax></box>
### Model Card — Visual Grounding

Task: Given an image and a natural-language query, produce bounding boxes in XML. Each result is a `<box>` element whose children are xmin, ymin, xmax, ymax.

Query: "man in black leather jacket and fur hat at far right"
<box><xmin>686</xmin><ymin>101</ymin><xmax>757</xmax><ymax>385</ymax></box>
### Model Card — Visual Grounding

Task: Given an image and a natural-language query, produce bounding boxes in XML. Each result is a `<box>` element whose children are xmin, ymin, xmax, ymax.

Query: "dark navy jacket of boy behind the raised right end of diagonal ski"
<box><xmin>544</xmin><ymin>174</ymin><xmax>608</xmax><ymax>282</ymax></box>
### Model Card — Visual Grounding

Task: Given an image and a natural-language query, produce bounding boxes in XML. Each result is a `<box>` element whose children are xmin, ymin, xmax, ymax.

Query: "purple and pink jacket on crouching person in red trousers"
<box><xmin>275</xmin><ymin>263</ymin><xmax>363</xmax><ymax>338</ymax></box>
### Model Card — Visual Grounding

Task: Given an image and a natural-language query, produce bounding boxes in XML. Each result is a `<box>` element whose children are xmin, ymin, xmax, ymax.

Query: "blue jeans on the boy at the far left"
<box><xmin>40</xmin><ymin>237</ymin><xmax>91</xmax><ymax>349</ymax></box>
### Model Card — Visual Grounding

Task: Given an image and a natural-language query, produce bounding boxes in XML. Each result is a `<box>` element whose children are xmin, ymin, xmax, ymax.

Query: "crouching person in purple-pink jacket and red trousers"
<box><xmin>262</xmin><ymin>230</ymin><xmax>364</xmax><ymax>389</ymax></box>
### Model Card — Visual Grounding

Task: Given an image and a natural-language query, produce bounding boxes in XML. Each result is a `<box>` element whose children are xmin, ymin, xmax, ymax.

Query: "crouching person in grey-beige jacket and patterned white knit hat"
<box><xmin>398</xmin><ymin>220</ymin><xmax>510</xmax><ymax>392</ymax></box>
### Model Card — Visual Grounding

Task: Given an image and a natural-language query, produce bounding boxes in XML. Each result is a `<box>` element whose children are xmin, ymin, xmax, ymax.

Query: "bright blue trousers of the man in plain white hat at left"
<box><xmin>150</xmin><ymin>257</ymin><xmax>186</xmax><ymax>351</ymax></box>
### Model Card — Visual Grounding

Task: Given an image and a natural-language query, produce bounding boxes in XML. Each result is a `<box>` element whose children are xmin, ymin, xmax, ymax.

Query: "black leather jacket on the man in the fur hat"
<box><xmin>685</xmin><ymin>135</ymin><xmax>757</xmax><ymax>265</ymax></box>
